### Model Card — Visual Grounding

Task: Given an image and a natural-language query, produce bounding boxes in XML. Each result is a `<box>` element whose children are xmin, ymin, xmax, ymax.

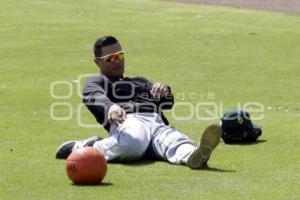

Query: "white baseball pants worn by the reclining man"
<box><xmin>93</xmin><ymin>113</ymin><xmax>196</xmax><ymax>164</ymax></box>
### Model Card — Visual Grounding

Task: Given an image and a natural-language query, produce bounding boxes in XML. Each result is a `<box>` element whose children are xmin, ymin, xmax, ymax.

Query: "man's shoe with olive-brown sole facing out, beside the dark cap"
<box><xmin>187</xmin><ymin>124</ymin><xmax>221</xmax><ymax>169</ymax></box>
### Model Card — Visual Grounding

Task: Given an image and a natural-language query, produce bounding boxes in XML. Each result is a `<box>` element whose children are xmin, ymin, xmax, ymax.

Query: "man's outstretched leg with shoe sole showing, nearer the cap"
<box><xmin>149</xmin><ymin>122</ymin><xmax>221</xmax><ymax>169</ymax></box>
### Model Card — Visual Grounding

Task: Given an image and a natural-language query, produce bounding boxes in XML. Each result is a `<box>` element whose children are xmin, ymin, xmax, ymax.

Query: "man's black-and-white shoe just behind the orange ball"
<box><xmin>55</xmin><ymin>136</ymin><xmax>103</xmax><ymax>159</ymax></box>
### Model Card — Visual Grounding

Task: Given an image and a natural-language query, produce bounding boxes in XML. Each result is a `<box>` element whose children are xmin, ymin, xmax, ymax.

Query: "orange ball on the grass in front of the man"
<box><xmin>66</xmin><ymin>147</ymin><xmax>107</xmax><ymax>185</ymax></box>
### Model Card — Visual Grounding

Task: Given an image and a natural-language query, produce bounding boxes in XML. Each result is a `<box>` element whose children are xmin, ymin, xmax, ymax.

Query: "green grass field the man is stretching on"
<box><xmin>0</xmin><ymin>0</ymin><xmax>300</xmax><ymax>200</ymax></box>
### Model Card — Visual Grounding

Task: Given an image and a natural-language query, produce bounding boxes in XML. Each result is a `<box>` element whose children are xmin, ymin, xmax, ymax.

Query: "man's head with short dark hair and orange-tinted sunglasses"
<box><xmin>94</xmin><ymin>36</ymin><xmax>124</xmax><ymax>78</ymax></box>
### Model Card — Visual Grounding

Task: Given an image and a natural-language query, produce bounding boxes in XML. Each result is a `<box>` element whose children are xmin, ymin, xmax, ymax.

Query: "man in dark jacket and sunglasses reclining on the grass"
<box><xmin>56</xmin><ymin>36</ymin><xmax>221</xmax><ymax>169</ymax></box>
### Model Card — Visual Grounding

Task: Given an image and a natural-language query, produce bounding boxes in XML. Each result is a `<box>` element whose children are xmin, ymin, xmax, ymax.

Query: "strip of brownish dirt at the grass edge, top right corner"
<box><xmin>169</xmin><ymin>0</ymin><xmax>300</xmax><ymax>13</ymax></box>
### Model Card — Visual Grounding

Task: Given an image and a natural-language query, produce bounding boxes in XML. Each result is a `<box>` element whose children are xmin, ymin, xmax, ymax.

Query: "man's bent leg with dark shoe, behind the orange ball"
<box><xmin>56</xmin><ymin>114</ymin><xmax>151</xmax><ymax>161</ymax></box>
